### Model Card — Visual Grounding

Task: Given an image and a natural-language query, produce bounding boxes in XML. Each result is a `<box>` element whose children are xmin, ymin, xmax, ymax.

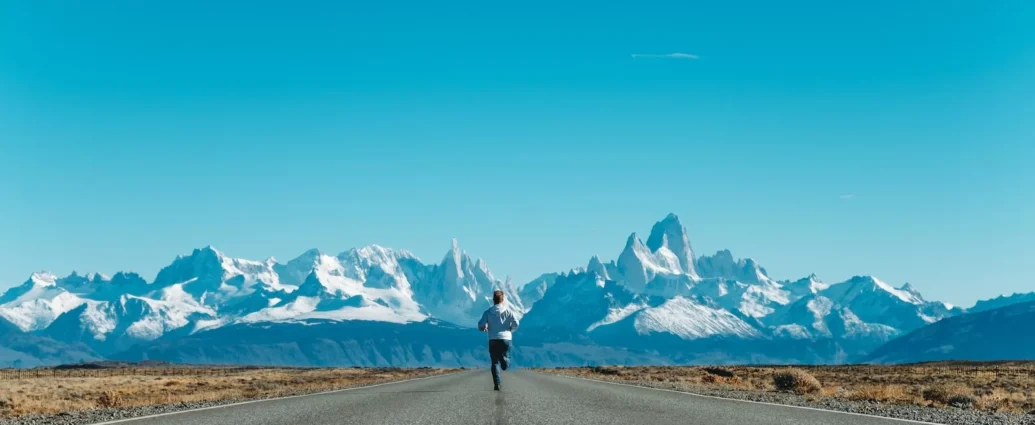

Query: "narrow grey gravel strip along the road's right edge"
<box><xmin>539</xmin><ymin>369</ymin><xmax>1035</xmax><ymax>425</ymax></box>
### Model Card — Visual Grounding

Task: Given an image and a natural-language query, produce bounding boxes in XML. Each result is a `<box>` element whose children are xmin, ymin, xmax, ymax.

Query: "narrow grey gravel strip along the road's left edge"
<box><xmin>0</xmin><ymin>370</ymin><xmax>460</xmax><ymax>425</ymax></box>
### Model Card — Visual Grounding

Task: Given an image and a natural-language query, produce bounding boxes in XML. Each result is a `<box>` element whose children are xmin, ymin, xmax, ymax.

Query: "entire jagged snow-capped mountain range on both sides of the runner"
<box><xmin>0</xmin><ymin>214</ymin><xmax>1019</xmax><ymax>363</ymax></box>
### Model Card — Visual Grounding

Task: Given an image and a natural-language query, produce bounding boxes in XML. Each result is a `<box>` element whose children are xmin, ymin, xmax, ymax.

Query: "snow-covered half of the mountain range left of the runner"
<box><xmin>0</xmin><ymin>240</ymin><xmax>517</xmax><ymax>355</ymax></box>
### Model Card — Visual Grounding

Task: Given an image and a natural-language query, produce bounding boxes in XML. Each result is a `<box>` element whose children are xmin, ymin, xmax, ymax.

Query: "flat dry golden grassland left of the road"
<box><xmin>0</xmin><ymin>368</ymin><xmax>451</xmax><ymax>418</ymax></box>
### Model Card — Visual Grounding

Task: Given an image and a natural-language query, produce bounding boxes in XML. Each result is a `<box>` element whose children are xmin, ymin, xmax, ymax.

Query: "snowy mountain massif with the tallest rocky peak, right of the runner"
<box><xmin>525</xmin><ymin>214</ymin><xmax>959</xmax><ymax>361</ymax></box>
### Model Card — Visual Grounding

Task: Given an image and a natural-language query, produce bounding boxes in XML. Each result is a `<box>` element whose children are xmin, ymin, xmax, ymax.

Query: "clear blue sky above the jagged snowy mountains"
<box><xmin>0</xmin><ymin>0</ymin><xmax>1035</xmax><ymax>304</ymax></box>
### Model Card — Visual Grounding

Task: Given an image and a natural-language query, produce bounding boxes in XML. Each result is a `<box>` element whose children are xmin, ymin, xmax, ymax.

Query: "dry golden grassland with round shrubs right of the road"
<box><xmin>540</xmin><ymin>362</ymin><xmax>1035</xmax><ymax>413</ymax></box>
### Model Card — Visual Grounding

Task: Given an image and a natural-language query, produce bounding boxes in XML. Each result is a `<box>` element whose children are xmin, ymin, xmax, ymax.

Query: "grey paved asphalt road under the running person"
<box><xmin>100</xmin><ymin>370</ymin><xmax>935</xmax><ymax>425</ymax></box>
